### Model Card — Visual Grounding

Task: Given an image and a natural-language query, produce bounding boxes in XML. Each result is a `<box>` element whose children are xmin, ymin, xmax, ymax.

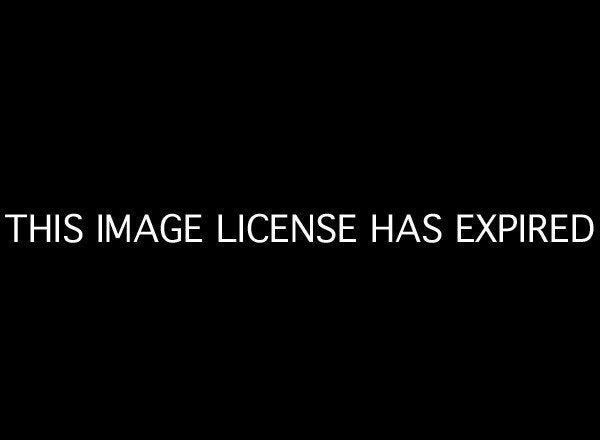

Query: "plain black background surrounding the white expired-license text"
<box><xmin>1</xmin><ymin>5</ymin><xmax>598</xmax><ymax>433</ymax></box>
